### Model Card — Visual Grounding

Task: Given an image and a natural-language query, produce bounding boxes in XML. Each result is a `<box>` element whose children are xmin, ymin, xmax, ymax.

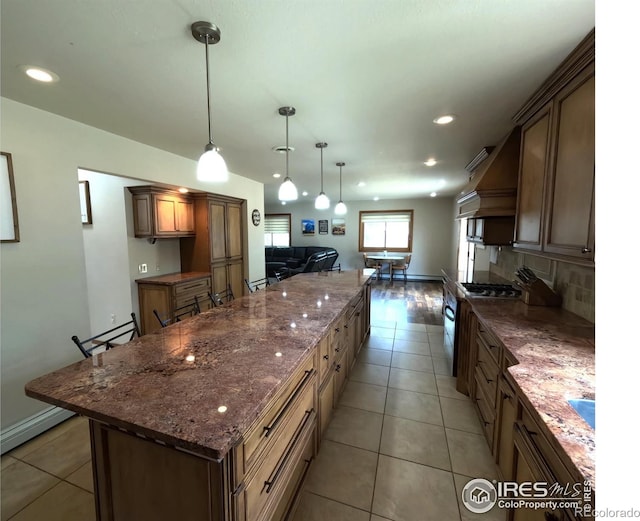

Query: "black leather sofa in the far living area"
<box><xmin>264</xmin><ymin>246</ymin><xmax>338</xmax><ymax>277</ymax></box>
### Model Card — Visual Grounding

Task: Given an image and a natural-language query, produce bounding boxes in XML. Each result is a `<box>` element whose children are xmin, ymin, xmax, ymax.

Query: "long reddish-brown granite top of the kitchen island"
<box><xmin>25</xmin><ymin>270</ymin><xmax>373</xmax><ymax>460</ymax></box>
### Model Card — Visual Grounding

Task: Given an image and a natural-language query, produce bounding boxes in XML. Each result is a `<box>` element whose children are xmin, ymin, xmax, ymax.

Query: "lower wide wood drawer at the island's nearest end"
<box><xmin>243</xmin><ymin>409</ymin><xmax>316</xmax><ymax>521</ymax></box>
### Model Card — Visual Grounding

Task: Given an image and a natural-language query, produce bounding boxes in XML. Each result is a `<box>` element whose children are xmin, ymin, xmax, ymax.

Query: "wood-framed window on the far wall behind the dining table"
<box><xmin>359</xmin><ymin>210</ymin><xmax>413</xmax><ymax>252</ymax></box>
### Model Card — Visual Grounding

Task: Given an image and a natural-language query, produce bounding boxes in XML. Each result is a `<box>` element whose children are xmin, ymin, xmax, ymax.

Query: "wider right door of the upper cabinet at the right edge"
<box><xmin>545</xmin><ymin>66</ymin><xmax>595</xmax><ymax>261</ymax></box>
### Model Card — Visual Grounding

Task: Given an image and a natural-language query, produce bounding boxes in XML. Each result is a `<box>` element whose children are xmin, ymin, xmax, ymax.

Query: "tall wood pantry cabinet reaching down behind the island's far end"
<box><xmin>180</xmin><ymin>194</ymin><xmax>246</xmax><ymax>297</ymax></box>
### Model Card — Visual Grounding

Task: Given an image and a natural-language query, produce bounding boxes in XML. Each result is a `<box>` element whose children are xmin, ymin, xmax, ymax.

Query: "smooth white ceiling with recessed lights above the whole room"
<box><xmin>1</xmin><ymin>0</ymin><xmax>595</xmax><ymax>204</ymax></box>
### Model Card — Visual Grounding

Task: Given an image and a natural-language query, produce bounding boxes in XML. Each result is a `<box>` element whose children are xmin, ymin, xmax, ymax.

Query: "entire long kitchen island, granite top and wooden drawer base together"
<box><xmin>25</xmin><ymin>270</ymin><xmax>373</xmax><ymax>521</ymax></box>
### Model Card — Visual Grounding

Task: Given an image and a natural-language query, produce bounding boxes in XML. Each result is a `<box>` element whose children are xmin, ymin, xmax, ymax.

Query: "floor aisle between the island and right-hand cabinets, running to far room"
<box><xmin>294</xmin><ymin>282</ymin><xmax>504</xmax><ymax>521</ymax></box>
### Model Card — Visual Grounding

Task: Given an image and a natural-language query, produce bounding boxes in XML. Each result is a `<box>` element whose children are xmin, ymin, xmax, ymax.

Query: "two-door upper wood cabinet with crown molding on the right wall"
<box><xmin>514</xmin><ymin>32</ymin><xmax>595</xmax><ymax>265</ymax></box>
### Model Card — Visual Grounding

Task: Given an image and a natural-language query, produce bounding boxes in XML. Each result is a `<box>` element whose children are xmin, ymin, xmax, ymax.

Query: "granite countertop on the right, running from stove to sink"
<box><xmin>469</xmin><ymin>298</ymin><xmax>595</xmax><ymax>487</ymax></box>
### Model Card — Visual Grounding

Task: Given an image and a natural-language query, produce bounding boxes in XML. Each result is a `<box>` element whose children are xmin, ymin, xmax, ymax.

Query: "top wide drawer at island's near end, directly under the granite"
<box><xmin>243</xmin><ymin>356</ymin><xmax>316</xmax><ymax>473</ymax></box>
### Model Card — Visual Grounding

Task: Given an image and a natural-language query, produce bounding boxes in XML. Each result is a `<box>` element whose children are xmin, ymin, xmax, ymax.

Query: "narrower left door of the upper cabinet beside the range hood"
<box><xmin>514</xmin><ymin>103</ymin><xmax>551</xmax><ymax>251</ymax></box>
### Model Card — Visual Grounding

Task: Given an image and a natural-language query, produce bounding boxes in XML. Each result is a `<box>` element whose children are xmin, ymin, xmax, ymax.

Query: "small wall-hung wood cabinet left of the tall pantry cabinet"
<box><xmin>129</xmin><ymin>186</ymin><xmax>195</xmax><ymax>239</ymax></box>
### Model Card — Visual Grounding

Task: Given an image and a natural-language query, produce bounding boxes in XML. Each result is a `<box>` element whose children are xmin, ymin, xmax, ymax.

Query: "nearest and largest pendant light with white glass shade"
<box><xmin>191</xmin><ymin>22</ymin><xmax>229</xmax><ymax>183</ymax></box>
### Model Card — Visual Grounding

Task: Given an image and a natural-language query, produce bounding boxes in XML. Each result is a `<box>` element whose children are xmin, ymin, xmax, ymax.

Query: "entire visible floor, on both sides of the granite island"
<box><xmin>0</xmin><ymin>282</ymin><xmax>504</xmax><ymax>521</ymax></box>
